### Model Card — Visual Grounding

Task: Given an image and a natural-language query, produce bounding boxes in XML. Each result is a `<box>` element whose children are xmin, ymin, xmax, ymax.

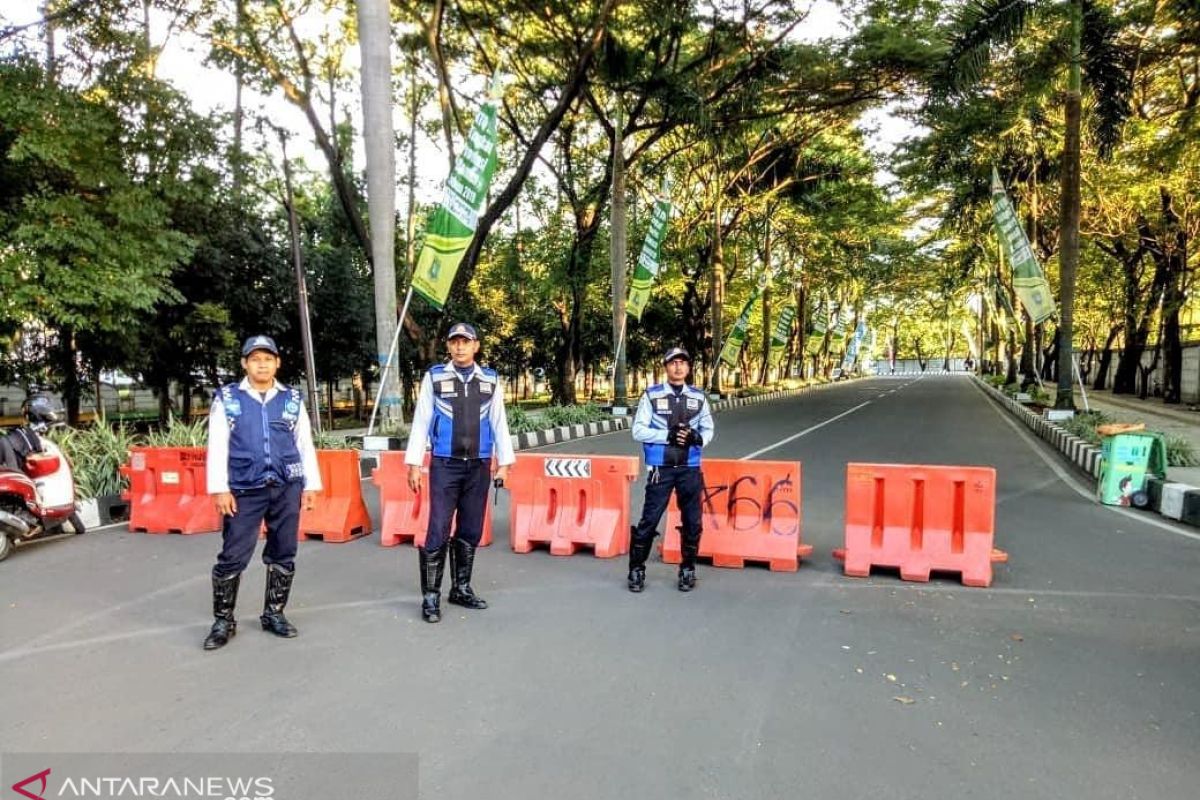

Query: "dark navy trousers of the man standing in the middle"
<box><xmin>425</xmin><ymin>456</ymin><xmax>492</xmax><ymax>551</ymax></box>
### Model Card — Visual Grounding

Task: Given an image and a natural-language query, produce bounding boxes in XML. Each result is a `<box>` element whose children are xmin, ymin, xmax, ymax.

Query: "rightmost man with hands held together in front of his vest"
<box><xmin>629</xmin><ymin>348</ymin><xmax>715</xmax><ymax>591</ymax></box>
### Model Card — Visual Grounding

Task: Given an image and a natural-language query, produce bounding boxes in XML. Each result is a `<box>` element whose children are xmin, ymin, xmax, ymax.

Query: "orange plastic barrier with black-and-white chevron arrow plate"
<box><xmin>509</xmin><ymin>453</ymin><xmax>638</xmax><ymax>558</ymax></box>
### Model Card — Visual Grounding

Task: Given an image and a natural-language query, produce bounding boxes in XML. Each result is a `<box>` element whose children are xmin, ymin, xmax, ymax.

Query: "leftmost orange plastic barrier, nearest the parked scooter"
<box><xmin>121</xmin><ymin>447</ymin><xmax>221</xmax><ymax>534</ymax></box>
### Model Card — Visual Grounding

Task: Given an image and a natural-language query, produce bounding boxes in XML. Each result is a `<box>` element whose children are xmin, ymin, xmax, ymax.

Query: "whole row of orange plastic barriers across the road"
<box><xmin>122</xmin><ymin>447</ymin><xmax>1008</xmax><ymax>587</ymax></box>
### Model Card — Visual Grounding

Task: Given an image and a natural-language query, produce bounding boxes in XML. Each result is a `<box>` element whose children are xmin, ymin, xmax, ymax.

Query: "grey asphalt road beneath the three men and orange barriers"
<box><xmin>0</xmin><ymin>377</ymin><xmax>1200</xmax><ymax>800</ymax></box>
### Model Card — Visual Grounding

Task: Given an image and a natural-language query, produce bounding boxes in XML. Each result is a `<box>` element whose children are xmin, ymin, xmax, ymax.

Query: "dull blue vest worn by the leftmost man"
<box><xmin>221</xmin><ymin>384</ymin><xmax>304</xmax><ymax>489</ymax></box>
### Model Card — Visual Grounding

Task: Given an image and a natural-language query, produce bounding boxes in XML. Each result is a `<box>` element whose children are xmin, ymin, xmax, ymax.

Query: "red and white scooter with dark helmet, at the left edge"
<box><xmin>0</xmin><ymin>395</ymin><xmax>86</xmax><ymax>561</ymax></box>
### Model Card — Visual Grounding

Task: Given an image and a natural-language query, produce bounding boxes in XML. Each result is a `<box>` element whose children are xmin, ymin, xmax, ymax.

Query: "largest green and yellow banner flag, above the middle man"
<box><xmin>413</xmin><ymin>76</ymin><xmax>500</xmax><ymax>308</ymax></box>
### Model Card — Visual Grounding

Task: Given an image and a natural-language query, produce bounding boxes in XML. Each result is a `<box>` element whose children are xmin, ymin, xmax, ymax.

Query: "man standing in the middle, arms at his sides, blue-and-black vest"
<box><xmin>404</xmin><ymin>323</ymin><xmax>516</xmax><ymax>622</ymax></box>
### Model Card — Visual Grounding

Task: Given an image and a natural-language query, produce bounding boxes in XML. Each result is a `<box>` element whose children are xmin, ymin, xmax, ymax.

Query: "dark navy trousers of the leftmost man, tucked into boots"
<box><xmin>212</xmin><ymin>481</ymin><xmax>304</xmax><ymax>578</ymax></box>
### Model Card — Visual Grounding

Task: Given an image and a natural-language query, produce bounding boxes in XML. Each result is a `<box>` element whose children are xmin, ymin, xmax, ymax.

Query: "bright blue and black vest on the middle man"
<box><xmin>428</xmin><ymin>362</ymin><xmax>499</xmax><ymax>458</ymax></box>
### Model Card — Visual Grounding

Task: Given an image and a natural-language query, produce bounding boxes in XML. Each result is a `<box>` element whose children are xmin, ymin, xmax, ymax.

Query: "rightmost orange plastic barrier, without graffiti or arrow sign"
<box><xmin>834</xmin><ymin>464</ymin><xmax>1008</xmax><ymax>587</ymax></box>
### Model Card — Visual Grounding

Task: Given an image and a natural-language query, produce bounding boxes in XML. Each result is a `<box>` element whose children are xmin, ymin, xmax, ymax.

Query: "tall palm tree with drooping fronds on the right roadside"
<box><xmin>934</xmin><ymin>0</ymin><xmax>1132</xmax><ymax>408</ymax></box>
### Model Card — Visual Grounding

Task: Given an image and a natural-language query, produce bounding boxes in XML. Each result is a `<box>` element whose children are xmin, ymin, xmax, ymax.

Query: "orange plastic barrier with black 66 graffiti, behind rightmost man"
<box><xmin>662</xmin><ymin>458</ymin><xmax>812</xmax><ymax>572</ymax></box>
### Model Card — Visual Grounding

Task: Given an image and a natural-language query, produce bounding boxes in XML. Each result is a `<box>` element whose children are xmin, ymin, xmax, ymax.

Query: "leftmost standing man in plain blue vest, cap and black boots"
<box><xmin>204</xmin><ymin>336</ymin><xmax>320</xmax><ymax>650</ymax></box>
